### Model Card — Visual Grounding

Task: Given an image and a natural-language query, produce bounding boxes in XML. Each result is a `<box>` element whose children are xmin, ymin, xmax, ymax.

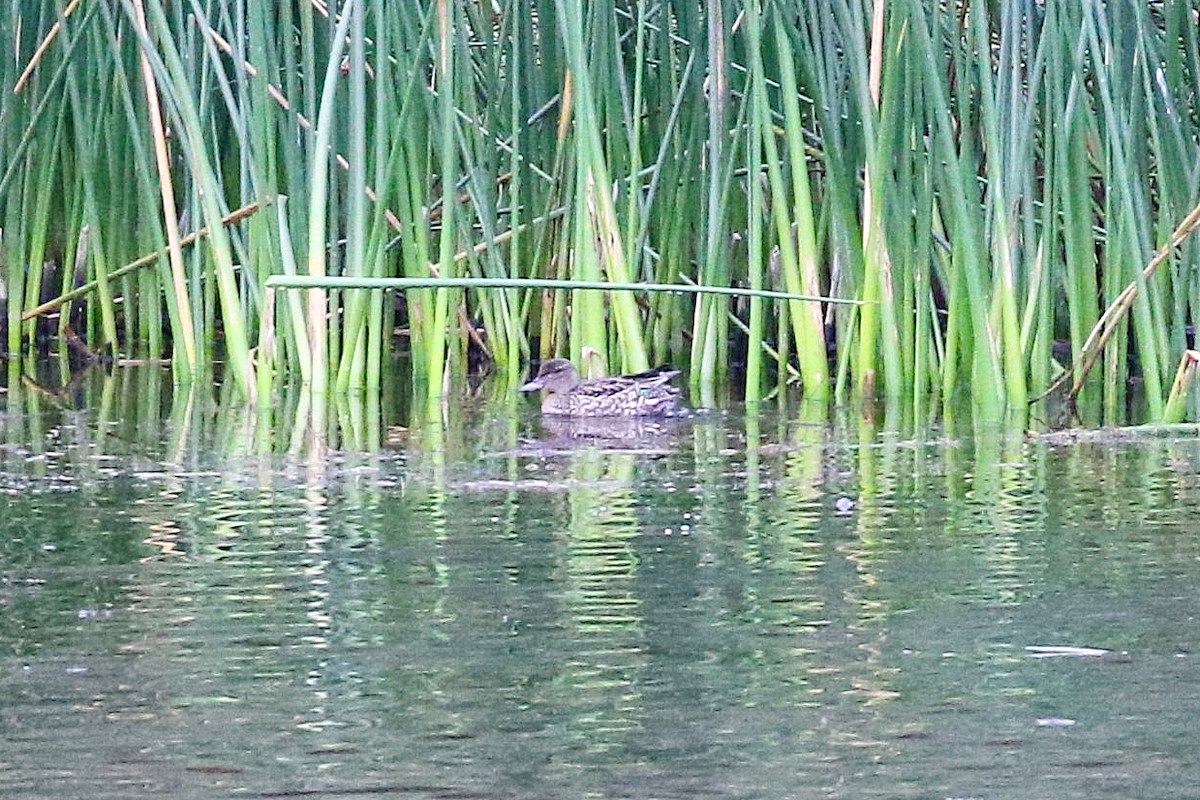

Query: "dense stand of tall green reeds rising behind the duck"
<box><xmin>7</xmin><ymin>0</ymin><xmax>1200</xmax><ymax>423</ymax></box>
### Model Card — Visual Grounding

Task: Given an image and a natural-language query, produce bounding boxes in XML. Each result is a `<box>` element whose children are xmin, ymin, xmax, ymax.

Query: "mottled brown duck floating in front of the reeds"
<box><xmin>517</xmin><ymin>359</ymin><xmax>679</xmax><ymax>417</ymax></box>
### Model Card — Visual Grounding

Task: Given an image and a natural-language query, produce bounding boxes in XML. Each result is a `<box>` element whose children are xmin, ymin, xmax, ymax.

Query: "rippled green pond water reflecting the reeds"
<box><xmin>0</xmin><ymin>371</ymin><xmax>1200</xmax><ymax>800</ymax></box>
